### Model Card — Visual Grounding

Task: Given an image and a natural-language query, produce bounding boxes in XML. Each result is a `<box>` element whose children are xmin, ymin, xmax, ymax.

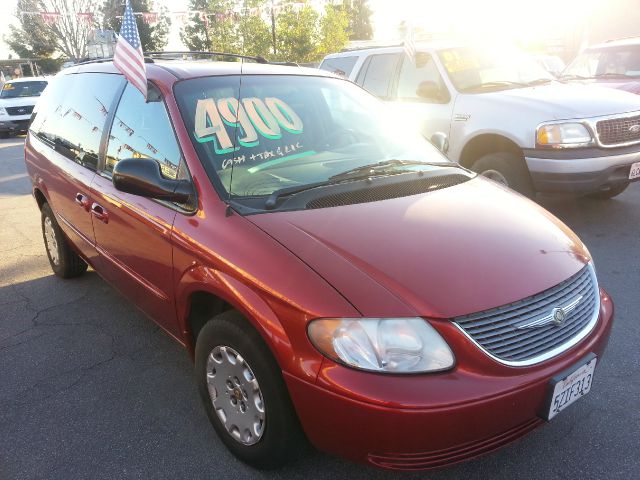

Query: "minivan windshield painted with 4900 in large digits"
<box><xmin>175</xmin><ymin>75</ymin><xmax>453</xmax><ymax>199</ymax></box>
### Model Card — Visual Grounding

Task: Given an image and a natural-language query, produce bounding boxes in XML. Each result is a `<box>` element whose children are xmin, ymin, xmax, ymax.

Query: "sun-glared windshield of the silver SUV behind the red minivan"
<box><xmin>438</xmin><ymin>47</ymin><xmax>553</xmax><ymax>92</ymax></box>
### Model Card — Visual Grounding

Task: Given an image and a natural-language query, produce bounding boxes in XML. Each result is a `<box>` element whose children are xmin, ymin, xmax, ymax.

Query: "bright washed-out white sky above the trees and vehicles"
<box><xmin>0</xmin><ymin>0</ymin><xmax>624</xmax><ymax>58</ymax></box>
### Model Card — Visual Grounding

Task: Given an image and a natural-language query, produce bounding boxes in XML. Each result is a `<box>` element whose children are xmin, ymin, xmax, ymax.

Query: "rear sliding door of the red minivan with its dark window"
<box><xmin>27</xmin><ymin>73</ymin><xmax>124</xmax><ymax>265</ymax></box>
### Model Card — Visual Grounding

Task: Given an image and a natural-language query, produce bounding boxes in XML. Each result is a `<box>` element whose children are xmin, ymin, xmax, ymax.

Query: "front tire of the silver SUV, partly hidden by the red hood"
<box><xmin>471</xmin><ymin>152</ymin><xmax>536</xmax><ymax>198</ymax></box>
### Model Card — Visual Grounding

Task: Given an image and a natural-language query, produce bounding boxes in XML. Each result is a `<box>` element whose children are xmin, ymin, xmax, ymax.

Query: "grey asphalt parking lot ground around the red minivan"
<box><xmin>0</xmin><ymin>137</ymin><xmax>640</xmax><ymax>480</ymax></box>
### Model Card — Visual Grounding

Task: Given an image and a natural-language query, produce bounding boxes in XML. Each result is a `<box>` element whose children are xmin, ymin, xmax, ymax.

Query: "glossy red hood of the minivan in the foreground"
<box><xmin>246</xmin><ymin>178</ymin><xmax>589</xmax><ymax>318</ymax></box>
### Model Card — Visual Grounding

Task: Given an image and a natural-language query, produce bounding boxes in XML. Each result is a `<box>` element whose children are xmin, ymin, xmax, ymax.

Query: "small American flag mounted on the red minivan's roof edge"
<box><xmin>113</xmin><ymin>0</ymin><xmax>147</xmax><ymax>98</ymax></box>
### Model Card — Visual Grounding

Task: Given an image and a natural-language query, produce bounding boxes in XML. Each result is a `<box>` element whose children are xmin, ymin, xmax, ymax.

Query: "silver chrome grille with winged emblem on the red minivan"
<box><xmin>453</xmin><ymin>265</ymin><xmax>600</xmax><ymax>365</ymax></box>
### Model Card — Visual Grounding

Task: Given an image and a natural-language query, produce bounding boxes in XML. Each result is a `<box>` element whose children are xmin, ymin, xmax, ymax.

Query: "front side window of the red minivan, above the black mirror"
<box><xmin>104</xmin><ymin>85</ymin><xmax>186</xmax><ymax>179</ymax></box>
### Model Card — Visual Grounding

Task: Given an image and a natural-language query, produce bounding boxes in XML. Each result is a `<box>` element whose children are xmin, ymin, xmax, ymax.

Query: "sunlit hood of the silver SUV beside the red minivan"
<box><xmin>476</xmin><ymin>82</ymin><xmax>640</xmax><ymax>120</ymax></box>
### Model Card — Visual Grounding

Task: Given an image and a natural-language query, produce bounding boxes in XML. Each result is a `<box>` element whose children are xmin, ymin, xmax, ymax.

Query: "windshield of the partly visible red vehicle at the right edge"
<box><xmin>562</xmin><ymin>46</ymin><xmax>640</xmax><ymax>78</ymax></box>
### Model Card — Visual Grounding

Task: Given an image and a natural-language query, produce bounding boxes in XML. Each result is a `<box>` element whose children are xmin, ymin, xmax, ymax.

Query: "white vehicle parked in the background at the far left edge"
<box><xmin>0</xmin><ymin>77</ymin><xmax>47</xmax><ymax>137</ymax></box>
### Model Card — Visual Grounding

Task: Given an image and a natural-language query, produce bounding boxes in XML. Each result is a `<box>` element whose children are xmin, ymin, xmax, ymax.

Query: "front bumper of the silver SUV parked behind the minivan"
<box><xmin>524</xmin><ymin>145</ymin><xmax>640</xmax><ymax>193</ymax></box>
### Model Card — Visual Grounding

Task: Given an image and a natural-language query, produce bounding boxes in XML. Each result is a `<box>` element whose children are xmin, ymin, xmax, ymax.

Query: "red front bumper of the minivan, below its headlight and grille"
<box><xmin>285</xmin><ymin>292</ymin><xmax>613</xmax><ymax>470</ymax></box>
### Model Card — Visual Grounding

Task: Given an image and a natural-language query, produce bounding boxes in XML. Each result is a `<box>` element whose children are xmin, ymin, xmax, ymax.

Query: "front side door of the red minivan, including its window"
<box><xmin>91</xmin><ymin>85</ymin><xmax>189</xmax><ymax>338</ymax></box>
